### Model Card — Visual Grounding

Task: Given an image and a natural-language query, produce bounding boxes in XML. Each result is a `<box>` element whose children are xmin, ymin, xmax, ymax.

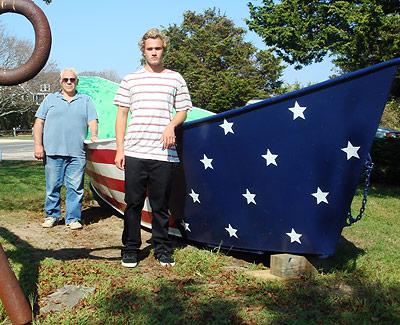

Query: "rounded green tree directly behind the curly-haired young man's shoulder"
<box><xmin>164</xmin><ymin>8</ymin><xmax>284</xmax><ymax>112</ymax></box>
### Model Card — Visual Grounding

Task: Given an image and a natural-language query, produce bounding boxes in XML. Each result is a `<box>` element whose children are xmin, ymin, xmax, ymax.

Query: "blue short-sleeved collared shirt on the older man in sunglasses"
<box><xmin>35</xmin><ymin>92</ymin><xmax>97</xmax><ymax>157</ymax></box>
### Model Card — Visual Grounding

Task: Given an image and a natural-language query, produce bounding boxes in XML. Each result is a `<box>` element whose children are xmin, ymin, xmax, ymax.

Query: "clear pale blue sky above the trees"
<box><xmin>0</xmin><ymin>0</ymin><xmax>332</xmax><ymax>84</ymax></box>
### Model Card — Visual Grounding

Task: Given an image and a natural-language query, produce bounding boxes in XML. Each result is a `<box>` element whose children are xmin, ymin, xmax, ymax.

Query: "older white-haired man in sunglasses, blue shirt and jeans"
<box><xmin>33</xmin><ymin>68</ymin><xmax>97</xmax><ymax>230</ymax></box>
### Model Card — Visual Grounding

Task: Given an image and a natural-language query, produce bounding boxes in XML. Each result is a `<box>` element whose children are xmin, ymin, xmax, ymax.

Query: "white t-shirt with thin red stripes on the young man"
<box><xmin>114</xmin><ymin>68</ymin><xmax>192</xmax><ymax>162</ymax></box>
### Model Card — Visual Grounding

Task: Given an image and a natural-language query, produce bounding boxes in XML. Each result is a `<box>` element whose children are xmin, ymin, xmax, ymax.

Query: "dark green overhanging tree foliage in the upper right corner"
<box><xmin>247</xmin><ymin>0</ymin><xmax>400</xmax><ymax>96</ymax></box>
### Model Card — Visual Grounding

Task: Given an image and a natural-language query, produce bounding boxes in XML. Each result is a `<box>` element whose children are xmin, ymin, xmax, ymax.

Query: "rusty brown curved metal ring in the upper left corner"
<box><xmin>0</xmin><ymin>0</ymin><xmax>51</xmax><ymax>86</ymax></box>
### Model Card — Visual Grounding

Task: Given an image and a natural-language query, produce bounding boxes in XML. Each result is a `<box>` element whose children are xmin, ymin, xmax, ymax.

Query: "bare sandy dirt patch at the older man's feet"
<box><xmin>0</xmin><ymin>206</ymin><xmax>151</xmax><ymax>258</ymax></box>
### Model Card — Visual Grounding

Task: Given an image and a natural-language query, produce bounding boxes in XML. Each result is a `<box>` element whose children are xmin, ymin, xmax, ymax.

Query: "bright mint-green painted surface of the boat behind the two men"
<box><xmin>77</xmin><ymin>76</ymin><xmax>214</xmax><ymax>139</ymax></box>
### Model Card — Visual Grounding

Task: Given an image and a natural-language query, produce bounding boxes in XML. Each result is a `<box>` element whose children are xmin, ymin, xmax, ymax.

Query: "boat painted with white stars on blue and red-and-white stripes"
<box><xmin>82</xmin><ymin>59</ymin><xmax>400</xmax><ymax>255</ymax></box>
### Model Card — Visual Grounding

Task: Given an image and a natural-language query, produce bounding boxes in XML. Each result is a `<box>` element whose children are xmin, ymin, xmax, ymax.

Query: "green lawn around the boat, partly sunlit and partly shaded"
<box><xmin>0</xmin><ymin>162</ymin><xmax>400</xmax><ymax>324</ymax></box>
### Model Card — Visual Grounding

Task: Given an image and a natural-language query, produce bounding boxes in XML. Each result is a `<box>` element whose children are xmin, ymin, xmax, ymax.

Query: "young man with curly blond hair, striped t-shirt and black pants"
<box><xmin>114</xmin><ymin>28</ymin><xmax>192</xmax><ymax>267</ymax></box>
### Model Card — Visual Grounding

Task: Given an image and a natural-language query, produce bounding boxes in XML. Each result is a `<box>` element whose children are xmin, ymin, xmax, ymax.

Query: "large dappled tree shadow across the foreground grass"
<box><xmin>92</xmin><ymin>274</ymin><xmax>400</xmax><ymax>324</ymax></box>
